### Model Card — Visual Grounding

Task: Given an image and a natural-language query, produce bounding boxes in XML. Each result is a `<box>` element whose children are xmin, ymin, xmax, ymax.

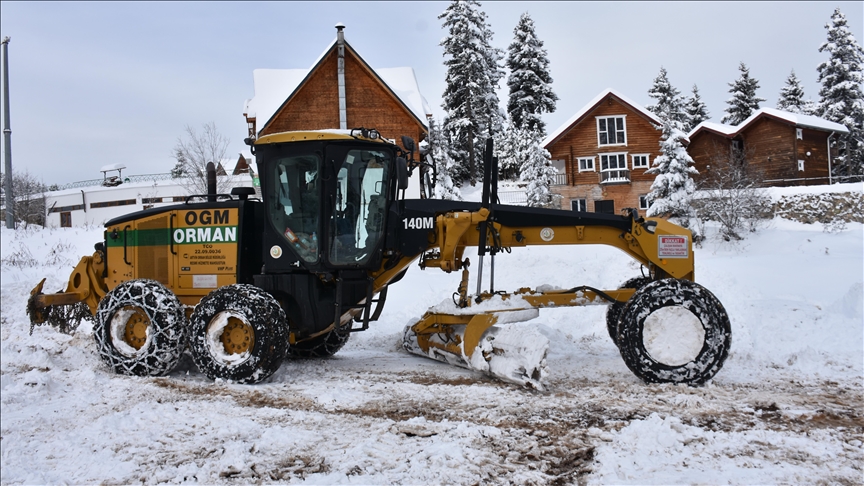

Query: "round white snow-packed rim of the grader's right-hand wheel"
<box><xmin>642</xmin><ymin>306</ymin><xmax>705</xmax><ymax>366</ymax></box>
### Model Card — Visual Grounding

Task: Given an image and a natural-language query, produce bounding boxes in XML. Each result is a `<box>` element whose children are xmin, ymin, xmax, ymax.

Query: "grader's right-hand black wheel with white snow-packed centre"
<box><xmin>618</xmin><ymin>279</ymin><xmax>732</xmax><ymax>385</ymax></box>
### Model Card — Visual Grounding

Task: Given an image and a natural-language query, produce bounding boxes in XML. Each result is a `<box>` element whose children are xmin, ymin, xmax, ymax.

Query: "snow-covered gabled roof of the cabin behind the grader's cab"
<box><xmin>243</xmin><ymin>39</ymin><xmax>432</xmax><ymax>136</ymax></box>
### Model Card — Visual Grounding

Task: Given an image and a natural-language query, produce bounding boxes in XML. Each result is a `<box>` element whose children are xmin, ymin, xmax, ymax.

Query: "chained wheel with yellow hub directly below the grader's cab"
<box><xmin>189</xmin><ymin>284</ymin><xmax>288</xmax><ymax>384</ymax></box>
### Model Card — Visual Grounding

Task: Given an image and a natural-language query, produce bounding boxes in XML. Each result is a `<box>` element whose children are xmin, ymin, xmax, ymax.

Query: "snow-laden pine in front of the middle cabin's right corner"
<box><xmin>645</xmin><ymin>120</ymin><xmax>699</xmax><ymax>227</ymax></box>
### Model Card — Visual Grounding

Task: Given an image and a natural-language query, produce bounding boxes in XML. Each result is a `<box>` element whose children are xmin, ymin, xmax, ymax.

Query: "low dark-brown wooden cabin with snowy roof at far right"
<box><xmin>687</xmin><ymin>108</ymin><xmax>848</xmax><ymax>187</ymax></box>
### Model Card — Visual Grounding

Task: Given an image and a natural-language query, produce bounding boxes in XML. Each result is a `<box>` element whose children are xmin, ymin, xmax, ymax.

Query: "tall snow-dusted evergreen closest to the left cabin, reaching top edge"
<box><xmin>438</xmin><ymin>0</ymin><xmax>504</xmax><ymax>186</ymax></box>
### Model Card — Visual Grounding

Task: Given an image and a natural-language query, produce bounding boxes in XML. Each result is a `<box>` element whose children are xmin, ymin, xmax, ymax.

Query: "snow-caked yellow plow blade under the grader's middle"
<box><xmin>403</xmin><ymin>309</ymin><xmax>549</xmax><ymax>390</ymax></box>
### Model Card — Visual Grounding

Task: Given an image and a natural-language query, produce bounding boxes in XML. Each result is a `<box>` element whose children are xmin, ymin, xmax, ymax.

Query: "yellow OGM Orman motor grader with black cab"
<box><xmin>28</xmin><ymin>128</ymin><xmax>731</xmax><ymax>388</ymax></box>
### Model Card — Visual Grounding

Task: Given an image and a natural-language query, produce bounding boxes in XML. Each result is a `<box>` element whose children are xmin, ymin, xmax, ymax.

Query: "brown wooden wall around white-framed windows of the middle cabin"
<box><xmin>546</xmin><ymin>94</ymin><xmax>662</xmax><ymax>214</ymax></box>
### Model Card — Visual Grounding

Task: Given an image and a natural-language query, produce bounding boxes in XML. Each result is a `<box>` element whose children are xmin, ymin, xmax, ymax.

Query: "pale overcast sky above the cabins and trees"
<box><xmin>0</xmin><ymin>1</ymin><xmax>864</xmax><ymax>184</ymax></box>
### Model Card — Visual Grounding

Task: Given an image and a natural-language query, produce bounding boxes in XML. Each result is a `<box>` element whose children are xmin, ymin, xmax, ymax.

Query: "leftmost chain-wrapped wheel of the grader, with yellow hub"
<box><xmin>93</xmin><ymin>279</ymin><xmax>186</xmax><ymax>376</ymax></box>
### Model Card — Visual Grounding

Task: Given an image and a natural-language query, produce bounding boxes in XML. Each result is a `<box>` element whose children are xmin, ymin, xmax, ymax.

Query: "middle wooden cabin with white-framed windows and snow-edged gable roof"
<box><xmin>543</xmin><ymin>89</ymin><xmax>662</xmax><ymax>214</ymax></box>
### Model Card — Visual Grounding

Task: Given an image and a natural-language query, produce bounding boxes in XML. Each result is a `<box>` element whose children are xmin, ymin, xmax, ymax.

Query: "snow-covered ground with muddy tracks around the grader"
<box><xmin>0</xmin><ymin>211</ymin><xmax>864</xmax><ymax>484</ymax></box>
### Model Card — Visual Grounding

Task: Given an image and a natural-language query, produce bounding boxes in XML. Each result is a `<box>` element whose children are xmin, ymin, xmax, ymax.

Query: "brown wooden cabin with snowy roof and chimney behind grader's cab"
<box><xmin>243</xmin><ymin>24</ymin><xmax>432</xmax><ymax>148</ymax></box>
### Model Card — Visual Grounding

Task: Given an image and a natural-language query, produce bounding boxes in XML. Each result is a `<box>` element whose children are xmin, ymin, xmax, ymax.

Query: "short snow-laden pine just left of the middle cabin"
<box><xmin>513</xmin><ymin>128</ymin><xmax>556</xmax><ymax>208</ymax></box>
